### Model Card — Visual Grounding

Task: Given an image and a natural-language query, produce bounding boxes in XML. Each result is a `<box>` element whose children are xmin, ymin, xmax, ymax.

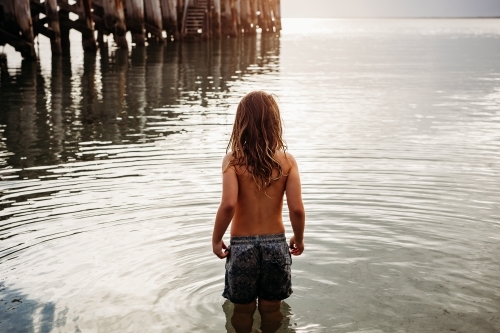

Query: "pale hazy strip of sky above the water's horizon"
<box><xmin>281</xmin><ymin>0</ymin><xmax>500</xmax><ymax>17</ymax></box>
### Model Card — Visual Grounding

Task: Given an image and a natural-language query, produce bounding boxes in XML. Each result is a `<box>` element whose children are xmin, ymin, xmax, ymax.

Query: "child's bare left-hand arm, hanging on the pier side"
<box><xmin>212</xmin><ymin>154</ymin><xmax>238</xmax><ymax>259</ymax></box>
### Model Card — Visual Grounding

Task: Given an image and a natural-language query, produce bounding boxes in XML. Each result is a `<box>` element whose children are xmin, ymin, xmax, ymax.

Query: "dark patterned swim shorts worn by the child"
<box><xmin>222</xmin><ymin>234</ymin><xmax>293</xmax><ymax>304</ymax></box>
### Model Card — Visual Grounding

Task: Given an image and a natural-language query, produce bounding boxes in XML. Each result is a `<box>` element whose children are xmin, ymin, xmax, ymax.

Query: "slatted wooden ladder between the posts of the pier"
<box><xmin>182</xmin><ymin>0</ymin><xmax>209</xmax><ymax>40</ymax></box>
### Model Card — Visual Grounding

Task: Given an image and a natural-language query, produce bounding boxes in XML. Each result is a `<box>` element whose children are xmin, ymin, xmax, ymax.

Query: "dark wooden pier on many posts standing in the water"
<box><xmin>0</xmin><ymin>0</ymin><xmax>281</xmax><ymax>60</ymax></box>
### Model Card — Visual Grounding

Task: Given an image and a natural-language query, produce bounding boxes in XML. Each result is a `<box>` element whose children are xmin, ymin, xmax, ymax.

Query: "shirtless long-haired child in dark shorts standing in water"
<box><xmin>212</xmin><ymin>91</ymin><xmax>305</xmax><ymax>333</ymax></box>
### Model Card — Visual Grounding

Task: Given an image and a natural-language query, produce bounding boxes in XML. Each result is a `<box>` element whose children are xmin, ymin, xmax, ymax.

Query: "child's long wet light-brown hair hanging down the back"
<box><xmin>226</xmin><ymin>91</ymin><xmax>287</xmax><ymax>191</ymax></box>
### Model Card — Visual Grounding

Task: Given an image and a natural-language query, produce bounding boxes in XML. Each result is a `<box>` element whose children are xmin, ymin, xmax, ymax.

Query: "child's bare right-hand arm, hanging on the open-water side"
<box><xmin>285</xmin><ymin>153</ymin><xmax>306</xmax><ymax>256</ymax></box>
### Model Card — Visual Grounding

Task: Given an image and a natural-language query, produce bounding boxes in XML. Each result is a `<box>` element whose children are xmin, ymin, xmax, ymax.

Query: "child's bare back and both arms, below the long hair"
<box><xmin>214</xmin><ymin>151</ymin><xmax>305</xmax><ymax>258</ymax></box>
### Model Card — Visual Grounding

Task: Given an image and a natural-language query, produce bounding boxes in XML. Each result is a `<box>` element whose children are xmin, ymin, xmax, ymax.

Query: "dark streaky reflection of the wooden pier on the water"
<box><xmin>0</xmin><ymin>35</ymin><xmax>279</xmax><ymax>177</ymax></box>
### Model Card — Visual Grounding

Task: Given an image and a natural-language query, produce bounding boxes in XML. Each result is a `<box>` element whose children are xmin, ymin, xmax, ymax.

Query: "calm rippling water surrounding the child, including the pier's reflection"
<box><xmin>0</xmin><ymin>19</ymin><xmax>500</xmax><ymax>333</ymax></box>
